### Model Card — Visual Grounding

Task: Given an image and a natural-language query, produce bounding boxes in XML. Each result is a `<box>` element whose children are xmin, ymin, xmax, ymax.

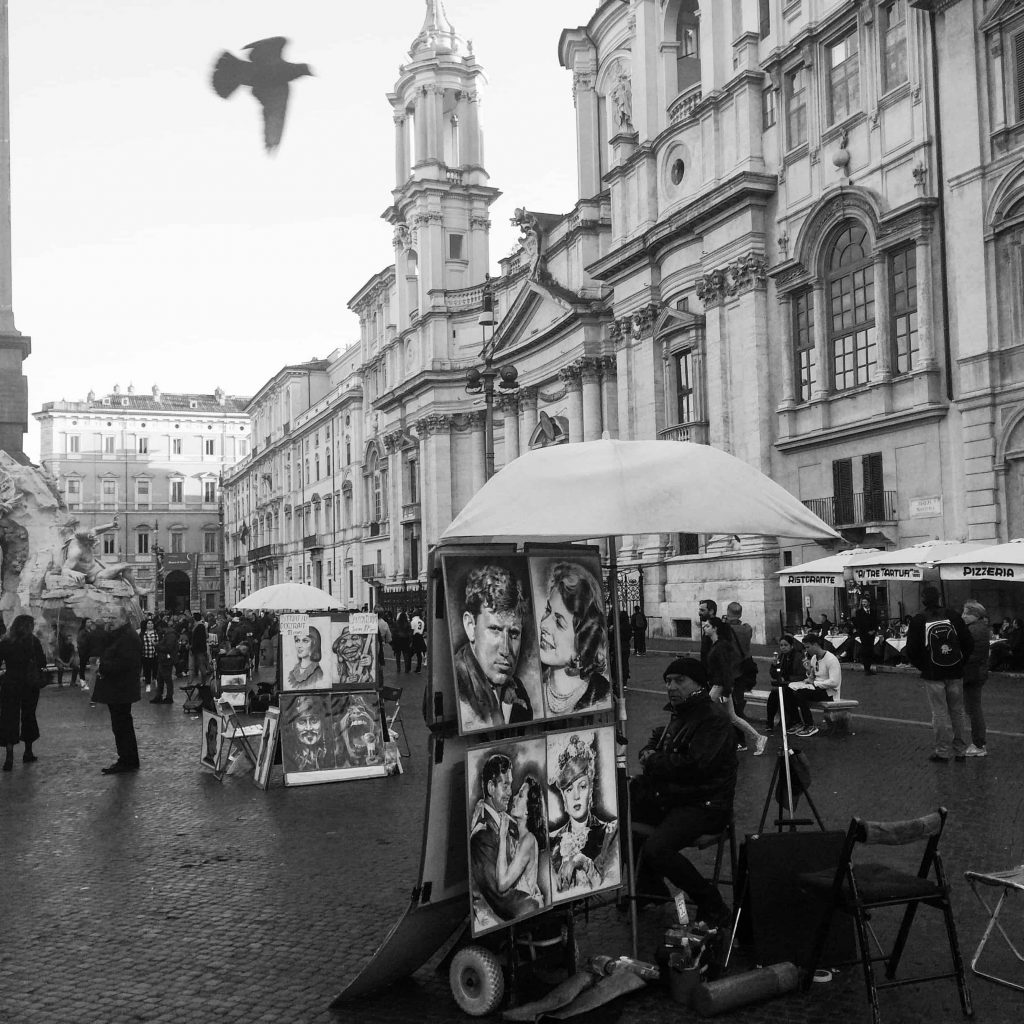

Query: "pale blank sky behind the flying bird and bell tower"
<box><xmin>10</xmin><ymin>0</ymin><xmax>598</xmax><ymax>456</ymax></box>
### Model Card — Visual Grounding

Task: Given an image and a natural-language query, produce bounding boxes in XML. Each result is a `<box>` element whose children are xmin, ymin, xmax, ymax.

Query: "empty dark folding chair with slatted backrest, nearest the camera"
<box><xmin>800</xmin><ymin>807</ymin><xmax>974</xmax><ymax>1024</ymax></box>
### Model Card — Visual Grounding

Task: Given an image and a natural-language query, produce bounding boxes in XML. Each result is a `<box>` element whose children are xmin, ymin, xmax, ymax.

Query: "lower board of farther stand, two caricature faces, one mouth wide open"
<box><xmin>281</xmin><ymin>690</ymin><xmax>388</xmax><ymax>785</ymax></box>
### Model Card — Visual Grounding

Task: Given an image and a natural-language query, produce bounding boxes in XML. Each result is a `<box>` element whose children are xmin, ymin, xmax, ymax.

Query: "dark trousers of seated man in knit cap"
<box><xmin>633</xmin><ymin>805</ymin><xmax>729</xmax><ymax>915</ymax></box>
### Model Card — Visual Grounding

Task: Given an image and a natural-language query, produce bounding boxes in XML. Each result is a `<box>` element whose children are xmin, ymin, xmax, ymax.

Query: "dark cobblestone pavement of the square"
<box><xmin>0</xmin><ymin>655</ymin><xmax>1024</xmax><ymax>1024</ymax></box>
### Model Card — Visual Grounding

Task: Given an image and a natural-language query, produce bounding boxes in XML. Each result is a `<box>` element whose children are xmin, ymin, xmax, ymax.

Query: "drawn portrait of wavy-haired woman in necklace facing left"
<box><xmin>530</xmin><ymin>554</ymin><xmax>611</xmax><ymax>718</ymax></box>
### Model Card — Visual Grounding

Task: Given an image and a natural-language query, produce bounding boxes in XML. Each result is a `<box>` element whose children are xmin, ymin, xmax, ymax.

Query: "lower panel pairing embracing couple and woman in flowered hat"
<box><xmin>466</xmin><ymin>726</ymin><xmax>622</xmax><ymax>936</ymax></box>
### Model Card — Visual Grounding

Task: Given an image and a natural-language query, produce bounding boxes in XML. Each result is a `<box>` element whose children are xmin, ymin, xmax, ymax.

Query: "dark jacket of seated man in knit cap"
<box><xmin>634</xmin><ymin>692</ymin><xmax>736</xmax><ymax>810</ymax></box>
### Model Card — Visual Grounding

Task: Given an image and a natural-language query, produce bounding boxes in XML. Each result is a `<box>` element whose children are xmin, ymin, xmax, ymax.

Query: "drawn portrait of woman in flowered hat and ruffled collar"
<box><xmin>547</xmin><ymin>726</ymin><xmax>622</xmax><ymax>902</ymax></box>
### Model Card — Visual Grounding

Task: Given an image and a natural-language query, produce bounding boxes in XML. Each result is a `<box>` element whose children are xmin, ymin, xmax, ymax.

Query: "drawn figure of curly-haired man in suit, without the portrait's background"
<box><xmin>454</xmin><ymin>565</ymin><xmax>534</xmax><ymax>728</ymax></box>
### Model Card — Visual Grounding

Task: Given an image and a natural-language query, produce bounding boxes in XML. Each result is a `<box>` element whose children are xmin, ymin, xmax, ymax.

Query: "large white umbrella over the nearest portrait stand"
<box><xmin>442</xmin><ymin>440</ymin><xmax>840</xmax><ymax>541</ymax></box>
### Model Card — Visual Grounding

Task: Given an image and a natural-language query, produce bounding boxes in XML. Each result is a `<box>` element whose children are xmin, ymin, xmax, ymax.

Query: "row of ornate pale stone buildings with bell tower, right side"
<box><xmin>225</xmin><ymin>0</ymin><xmax>1024</xmax><ymax>639</ymax></box>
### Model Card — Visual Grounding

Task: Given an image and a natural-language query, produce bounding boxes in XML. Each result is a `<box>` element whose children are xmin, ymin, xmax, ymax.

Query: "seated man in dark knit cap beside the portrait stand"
<box><xmin>630</xmin><ymin>657</ymin><xmax>736</xmax><ymax>927</ymax></box>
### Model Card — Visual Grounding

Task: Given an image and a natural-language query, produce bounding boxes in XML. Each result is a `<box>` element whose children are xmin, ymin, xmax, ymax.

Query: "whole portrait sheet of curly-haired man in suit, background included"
<box><xmin>444</xmin><ymin>555</ymin><xmax>544</xmax><ymax>733</ymax></box>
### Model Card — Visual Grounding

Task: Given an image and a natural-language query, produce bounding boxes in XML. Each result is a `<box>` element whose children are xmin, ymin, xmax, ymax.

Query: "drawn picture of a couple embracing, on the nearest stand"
<box><xmin>466</xmin><ymin>737</ymin><xmax>551</xmax><ymax>935</ymax></box>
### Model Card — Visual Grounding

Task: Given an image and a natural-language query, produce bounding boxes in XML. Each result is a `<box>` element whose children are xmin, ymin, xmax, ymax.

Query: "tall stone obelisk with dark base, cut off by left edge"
<box><xmin>0</xmin><ymin>0</ymin><xmax>32</xmax><ymax>462</ymax></box>
